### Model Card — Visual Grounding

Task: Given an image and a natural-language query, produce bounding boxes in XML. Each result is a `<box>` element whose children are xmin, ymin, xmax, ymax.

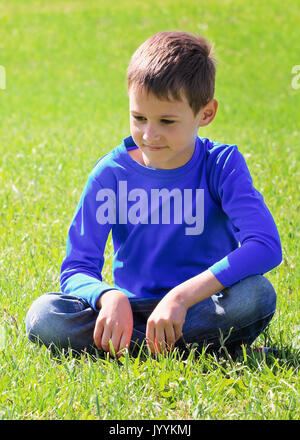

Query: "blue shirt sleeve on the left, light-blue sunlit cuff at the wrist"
<box><xmin>60</xmin><ymin>176</ymin><xmax>115</xmax><ymax>311</ymax></box>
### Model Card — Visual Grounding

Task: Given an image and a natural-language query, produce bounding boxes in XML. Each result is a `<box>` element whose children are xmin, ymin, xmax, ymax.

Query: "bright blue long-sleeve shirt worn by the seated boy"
<box><xmin>60</xmin><ymin>136</ymin><xmax>282</xmax><ymax>311</ymax></box>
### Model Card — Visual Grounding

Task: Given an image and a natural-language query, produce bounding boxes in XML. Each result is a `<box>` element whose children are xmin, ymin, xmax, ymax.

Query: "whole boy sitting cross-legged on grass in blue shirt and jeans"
<box><xmin>26</xmin><ymin>31</ymin><xmax>282</xmax><ymax>356</ymax></box>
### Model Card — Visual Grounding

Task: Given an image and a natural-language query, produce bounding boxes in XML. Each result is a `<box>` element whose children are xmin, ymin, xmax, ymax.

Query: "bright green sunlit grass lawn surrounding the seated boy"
<box><xmin>0</xmin><ymin>0</ymin><xmax>300</xmax><ymax>420</ymax></box>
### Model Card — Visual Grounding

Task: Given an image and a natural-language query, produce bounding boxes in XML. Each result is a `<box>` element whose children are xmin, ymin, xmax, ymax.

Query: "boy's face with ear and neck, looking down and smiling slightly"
<box><xmin>128</xmin><ymin>88</ymin><xmax>217</xmax><ymax>169</ymax></box>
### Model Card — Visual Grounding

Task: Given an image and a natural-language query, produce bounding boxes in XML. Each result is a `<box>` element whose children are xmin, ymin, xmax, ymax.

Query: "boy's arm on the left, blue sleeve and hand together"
<box><xmin>61</xmin><ymin>176</ymin><xmax>133</xmax><ymax>356</ymax></box>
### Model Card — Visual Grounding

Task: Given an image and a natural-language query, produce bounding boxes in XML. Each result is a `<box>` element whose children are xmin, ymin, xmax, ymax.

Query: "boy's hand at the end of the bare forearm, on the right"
<box><xmin>146</xmin><ymin>290</ymin><xmax>187</xmax><ymax>354</ymax></box>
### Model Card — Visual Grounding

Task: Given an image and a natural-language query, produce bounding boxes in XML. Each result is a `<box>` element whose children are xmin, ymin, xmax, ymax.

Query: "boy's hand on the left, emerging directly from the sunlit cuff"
<box><xmin>94</xmin><ymin>290</ymin><xmax>133</xmax><ymax>357</ymax></box>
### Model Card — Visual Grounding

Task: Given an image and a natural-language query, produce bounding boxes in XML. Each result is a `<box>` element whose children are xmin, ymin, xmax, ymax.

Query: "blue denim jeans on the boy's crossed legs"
<box><xmin>26</xmin><ymin>275</ymin><xmax>276</xmax><ymax>354</ymax></box>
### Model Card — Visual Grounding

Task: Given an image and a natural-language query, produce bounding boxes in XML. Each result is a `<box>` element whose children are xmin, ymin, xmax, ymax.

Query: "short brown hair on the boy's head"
<box><xmin>127</xmin><ymin>31</ymin><xmax>216</xmax><ymax>115</ymax></box>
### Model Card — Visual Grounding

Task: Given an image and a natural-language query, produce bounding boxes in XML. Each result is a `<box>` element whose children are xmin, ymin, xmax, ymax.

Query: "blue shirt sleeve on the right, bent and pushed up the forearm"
<box><xmin>209</xmin><ymin>146</ymin><xmax>282</xmax><ymax>287</ymax></box>
